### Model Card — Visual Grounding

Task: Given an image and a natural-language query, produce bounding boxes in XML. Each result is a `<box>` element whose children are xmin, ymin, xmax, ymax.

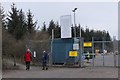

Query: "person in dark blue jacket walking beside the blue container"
<box><xmin>42</xmin><ymin>51</ymin><xmax>49</xmax><ymax>70</ymax></box>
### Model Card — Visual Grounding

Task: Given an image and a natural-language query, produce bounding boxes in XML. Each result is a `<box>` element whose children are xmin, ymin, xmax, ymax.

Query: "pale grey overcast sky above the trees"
<box><xmin>2</xmin><ymin>2</ymin><xmax>118</xmax><ymax>37</ymax></box>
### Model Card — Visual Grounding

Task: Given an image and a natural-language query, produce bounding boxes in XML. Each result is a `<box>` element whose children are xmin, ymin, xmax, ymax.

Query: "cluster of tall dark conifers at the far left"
<box><xmin>2</xmin><ymin>4</ymin><xmax>37</xmax><ymax>40</ymax></box>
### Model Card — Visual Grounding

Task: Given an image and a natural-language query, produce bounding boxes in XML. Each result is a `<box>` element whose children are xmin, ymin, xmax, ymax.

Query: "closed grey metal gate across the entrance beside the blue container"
<box><xmin>82</xmin><ymin>38</ymin><xmax>118</xmax><ymax>67</ymax></box>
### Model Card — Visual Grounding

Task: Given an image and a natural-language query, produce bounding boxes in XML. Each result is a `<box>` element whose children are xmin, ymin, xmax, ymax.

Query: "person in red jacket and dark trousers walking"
<box><xmin>24</xmin><ymin>49</ymin><xmax>32</xmax><ymax>70</ymax></box>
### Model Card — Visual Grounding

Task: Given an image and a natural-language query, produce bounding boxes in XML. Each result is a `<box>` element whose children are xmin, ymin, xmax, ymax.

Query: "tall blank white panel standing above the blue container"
<box><xmin>60</xmin><ymin>15</ymin><xmax>72</xmax><ymax>38</ymax></box>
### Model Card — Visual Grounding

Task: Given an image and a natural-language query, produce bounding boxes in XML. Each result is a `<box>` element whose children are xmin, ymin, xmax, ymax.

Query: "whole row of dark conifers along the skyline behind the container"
<box><xmin>1</xmin><ymin>4</ymin><xmax>111</xmax><ymax>41</ymax></box>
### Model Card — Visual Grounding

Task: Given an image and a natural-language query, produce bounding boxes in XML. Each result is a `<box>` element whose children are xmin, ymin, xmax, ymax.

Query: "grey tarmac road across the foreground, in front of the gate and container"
<box><xmin>2</xmin><ymin>67</ymin><xmax>118</xmax><ymax>78</ymax></box>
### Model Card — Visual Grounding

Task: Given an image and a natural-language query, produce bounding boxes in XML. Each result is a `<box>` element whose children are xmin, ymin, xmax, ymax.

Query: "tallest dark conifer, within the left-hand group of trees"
<box><xmin>7</xmin><ymin>4</ymin><xmax>27</xmax><ymax>40</ymax></box>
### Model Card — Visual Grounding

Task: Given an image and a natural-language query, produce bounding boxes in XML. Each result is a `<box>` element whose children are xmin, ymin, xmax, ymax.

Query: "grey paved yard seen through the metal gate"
<box><xmin>84</xmin><ymin>53</ymin><xmax>118</xmax><ymax>67</ymax></box>
